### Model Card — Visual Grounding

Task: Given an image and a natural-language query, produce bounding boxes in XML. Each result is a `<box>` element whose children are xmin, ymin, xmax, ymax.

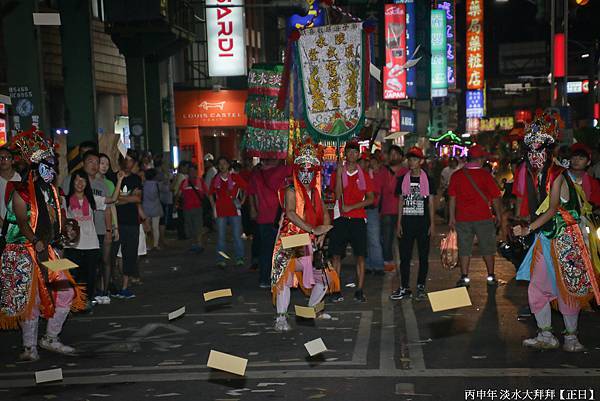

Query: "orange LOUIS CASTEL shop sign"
<box><xmin>175</xmin><ymin>90</ymin><xmax>248</xmax><ymax>127</ymax></box>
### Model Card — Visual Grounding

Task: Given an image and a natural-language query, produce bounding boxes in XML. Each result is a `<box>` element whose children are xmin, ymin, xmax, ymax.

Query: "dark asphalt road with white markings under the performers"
<box><xmin>0</xmin><ymin>230</ymin><xmax>600</xmax><ymax>401</ymax></box>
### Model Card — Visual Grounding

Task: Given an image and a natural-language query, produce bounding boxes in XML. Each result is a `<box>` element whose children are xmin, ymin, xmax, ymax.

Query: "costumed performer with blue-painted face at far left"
<box><xmin>0</xmin><ymin>129</ymin><xmax>86</xmax><ymax>361</ymax></box>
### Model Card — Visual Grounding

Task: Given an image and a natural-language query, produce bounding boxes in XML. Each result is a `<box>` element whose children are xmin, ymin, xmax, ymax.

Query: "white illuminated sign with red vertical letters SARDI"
<box><xmin>206</xmin><ymin>0</ymin><xmax>247</xmax><ymax>77</ymax></box>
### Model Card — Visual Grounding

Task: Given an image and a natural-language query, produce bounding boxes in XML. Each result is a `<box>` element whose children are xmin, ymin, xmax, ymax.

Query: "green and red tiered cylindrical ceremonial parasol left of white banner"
<box><xmin>242</xmin><ymin>64</ymin><xmax>289</xmax><ymax>159</ymax></box>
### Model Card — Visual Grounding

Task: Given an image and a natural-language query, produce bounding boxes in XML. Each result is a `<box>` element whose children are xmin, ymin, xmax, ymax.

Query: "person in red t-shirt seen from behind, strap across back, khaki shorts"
<box><xmin>448</xmin><ymin>145</ymin><xmax>502</xmax><ymax>286</ymax></box>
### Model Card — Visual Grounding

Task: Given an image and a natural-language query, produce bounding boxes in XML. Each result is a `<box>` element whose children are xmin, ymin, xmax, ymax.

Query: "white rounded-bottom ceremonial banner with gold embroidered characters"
<box><xmin>296</xmin><ymin>23</ymin><xmax>369</xmax><ymax>143</ymax></box>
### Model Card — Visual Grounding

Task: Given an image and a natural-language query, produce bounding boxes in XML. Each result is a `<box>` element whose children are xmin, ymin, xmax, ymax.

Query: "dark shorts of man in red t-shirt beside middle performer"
<box><xmin>329</xmin><ymin>217</ymin><xmax>367</xmax><ymax>257</ymax></box>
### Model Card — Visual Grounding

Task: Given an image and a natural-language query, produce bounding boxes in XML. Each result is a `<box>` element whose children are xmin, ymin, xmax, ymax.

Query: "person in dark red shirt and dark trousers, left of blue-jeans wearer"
<box><xmin>179</xmin><ymin>164</ymin><xmax>208</xmax><ymax>253</ymax></box>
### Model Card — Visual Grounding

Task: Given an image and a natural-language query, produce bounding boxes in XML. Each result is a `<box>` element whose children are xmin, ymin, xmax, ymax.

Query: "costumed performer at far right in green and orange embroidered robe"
<box><xmin>513</xmin><ymin>115</ymin><xmax>600</xmax><ymax>352</ymax></box>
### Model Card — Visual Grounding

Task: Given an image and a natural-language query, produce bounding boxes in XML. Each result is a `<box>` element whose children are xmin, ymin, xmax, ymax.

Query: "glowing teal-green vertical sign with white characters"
<box><xmin>431</xmin><ymin>10</ymin><xmax>448</xmax><ymax>97</ymax></box>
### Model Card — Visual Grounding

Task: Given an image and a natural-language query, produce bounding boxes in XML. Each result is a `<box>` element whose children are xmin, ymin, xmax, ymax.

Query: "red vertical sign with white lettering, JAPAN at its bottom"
<box><xmin>383</xmin><ymin>4</ymin><xmax>406</xmax><ymax>100</ymax></box>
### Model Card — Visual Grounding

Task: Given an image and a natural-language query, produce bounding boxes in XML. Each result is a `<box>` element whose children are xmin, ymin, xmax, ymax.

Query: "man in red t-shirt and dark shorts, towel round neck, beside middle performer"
<box><xmin>329</xmin><ymin>141</ymin><xmax>373</xmax><ymax>302</ymax></box>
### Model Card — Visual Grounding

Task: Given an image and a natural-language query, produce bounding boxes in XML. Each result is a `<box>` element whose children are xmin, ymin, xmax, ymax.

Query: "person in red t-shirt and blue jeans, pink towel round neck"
<box><xmin>209</xmin><ymin>156</ymin><xmax>247</xmax><ymax>268</ymax></box>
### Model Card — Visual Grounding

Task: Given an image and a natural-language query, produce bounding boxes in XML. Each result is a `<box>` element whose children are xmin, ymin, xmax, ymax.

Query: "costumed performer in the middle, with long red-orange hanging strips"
<box><xmin>271</xmin><ymin>139</ymin><xmax>339</xmax><ymax>332</ymax></box>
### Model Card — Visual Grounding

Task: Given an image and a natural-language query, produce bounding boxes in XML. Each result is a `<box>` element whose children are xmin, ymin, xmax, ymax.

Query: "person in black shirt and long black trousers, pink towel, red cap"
<box><xmin>390</xmin><ymin>147</ymin><xmax>435</xmax><ymax>300</ymax></box>
